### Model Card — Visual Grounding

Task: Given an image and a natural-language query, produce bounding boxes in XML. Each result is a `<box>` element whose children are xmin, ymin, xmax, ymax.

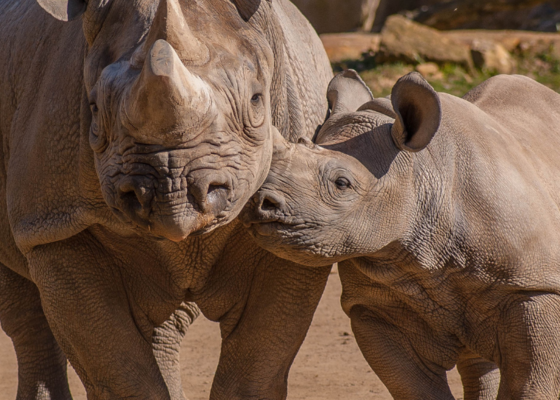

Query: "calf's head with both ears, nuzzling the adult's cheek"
<box><xmin>241</xmin><ymin>71</ymin><xmax>441</xmax><ymax>266</ymax></box>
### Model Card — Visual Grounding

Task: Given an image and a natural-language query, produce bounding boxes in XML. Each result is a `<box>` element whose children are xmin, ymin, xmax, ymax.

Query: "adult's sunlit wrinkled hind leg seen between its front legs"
<box><xmin>152</xmin><ymin>302</ymin><xmax>200</xmax><ymax>400</ymax></box>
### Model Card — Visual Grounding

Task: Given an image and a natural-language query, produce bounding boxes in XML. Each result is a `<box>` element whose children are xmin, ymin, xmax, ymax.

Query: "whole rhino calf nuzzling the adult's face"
<box><xmin>242</xmin><ymin>71</ymin><xmax>560</xmax><ymax>400</ymax></box>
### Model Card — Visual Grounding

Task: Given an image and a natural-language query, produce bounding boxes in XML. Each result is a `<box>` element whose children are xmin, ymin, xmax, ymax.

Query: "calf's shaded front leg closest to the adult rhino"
<box><xmin>350</xmin><ymin>305</ymin><xmax>454</xmax><ymax>400</ymax></box>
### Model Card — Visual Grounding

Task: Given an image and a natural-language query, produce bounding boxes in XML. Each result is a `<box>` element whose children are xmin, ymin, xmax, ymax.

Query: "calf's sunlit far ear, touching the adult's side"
<box><xmin>327</xmin><ymin>69</ymin><xmax>373</xmax><ymax>114</ymax></box>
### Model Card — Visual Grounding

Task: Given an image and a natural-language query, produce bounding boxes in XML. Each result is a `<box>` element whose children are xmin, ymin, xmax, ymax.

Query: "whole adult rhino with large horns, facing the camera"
<box><xmin>0</xmin><ymin>0</ymin><xmax>332</xmax><ymax>400</ymax></box>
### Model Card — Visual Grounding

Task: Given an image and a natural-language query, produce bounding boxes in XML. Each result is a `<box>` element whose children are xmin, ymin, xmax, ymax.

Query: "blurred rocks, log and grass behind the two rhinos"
<box><xmin>292</xmin><ymin>0</ymin><xmax>560</xmax><ymax>96</ymax></box>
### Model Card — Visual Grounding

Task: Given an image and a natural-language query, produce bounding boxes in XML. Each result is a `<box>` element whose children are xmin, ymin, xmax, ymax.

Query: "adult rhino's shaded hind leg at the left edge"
<box><xmin>0</xmin><ymin>265</ymin><xmax>72</xmax><ymax>400</ymax></box>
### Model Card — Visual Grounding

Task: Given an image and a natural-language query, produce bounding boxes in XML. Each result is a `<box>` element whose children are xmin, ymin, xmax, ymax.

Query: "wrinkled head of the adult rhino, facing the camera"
<box><xmin>39</xmin><ymin>0</ymin><xmax>275</xmax><ymax>241</ymax></box>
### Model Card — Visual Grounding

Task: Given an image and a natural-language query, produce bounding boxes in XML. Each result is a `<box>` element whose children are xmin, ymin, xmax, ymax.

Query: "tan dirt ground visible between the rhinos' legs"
<box><xmin>0</xmin><ymin>273</ymin><xmax>462</xmax><ymax>400</ymax></box>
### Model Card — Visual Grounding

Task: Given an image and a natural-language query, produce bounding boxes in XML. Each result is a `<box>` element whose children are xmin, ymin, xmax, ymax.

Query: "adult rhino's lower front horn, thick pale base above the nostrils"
<box><xmin>126</xmin><ymin>39</ymin><xmax>212</xmax><ymax>144</ymax></box>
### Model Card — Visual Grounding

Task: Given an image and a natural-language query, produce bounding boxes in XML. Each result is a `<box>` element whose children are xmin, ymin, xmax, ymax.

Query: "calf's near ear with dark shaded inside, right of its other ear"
<box><xmin>391</xmin><ymin>72</ymin><xmax>441</xmax><ymax>152</ymax></box>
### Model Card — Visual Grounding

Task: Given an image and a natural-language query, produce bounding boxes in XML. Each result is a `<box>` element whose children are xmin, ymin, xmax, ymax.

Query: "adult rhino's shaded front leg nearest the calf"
<box><xmin>197</xmin><ymin>242</ymin><xmax>331</xmax><ymax>400</ymax></box>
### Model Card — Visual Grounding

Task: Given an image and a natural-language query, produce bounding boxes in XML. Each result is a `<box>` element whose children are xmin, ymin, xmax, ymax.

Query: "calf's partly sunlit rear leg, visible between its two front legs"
<box><xmin>457</xmin><ymin>350</ymin><xmax>500</xmax><ymax>400</ymax></box>
